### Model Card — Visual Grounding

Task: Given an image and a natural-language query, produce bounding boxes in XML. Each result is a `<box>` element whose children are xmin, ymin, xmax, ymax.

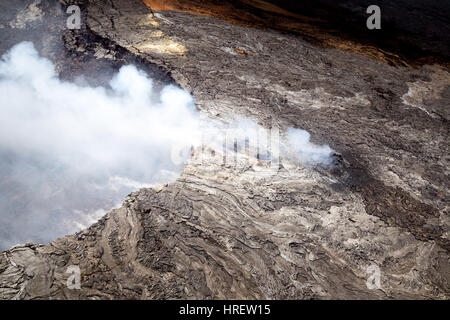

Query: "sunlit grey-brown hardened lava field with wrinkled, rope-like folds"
<box><xmin>0</xmin><ymin>0</ymin><xmax>450</xmax><ymax>299</ymax></box>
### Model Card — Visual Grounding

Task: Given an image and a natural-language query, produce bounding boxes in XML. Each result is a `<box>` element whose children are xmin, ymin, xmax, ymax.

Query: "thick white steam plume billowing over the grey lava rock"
<box><xmin>0</xmin><ymin>42</ymin><xmax>331</xmax><ymax>249</ymax></box>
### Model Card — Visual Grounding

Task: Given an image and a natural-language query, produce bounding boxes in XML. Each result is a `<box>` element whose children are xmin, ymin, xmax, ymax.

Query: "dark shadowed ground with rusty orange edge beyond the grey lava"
<box><xmin>143</xmin><ymin>0</ymin><xmax>450</xmax><ymax>67</ymax></box>
